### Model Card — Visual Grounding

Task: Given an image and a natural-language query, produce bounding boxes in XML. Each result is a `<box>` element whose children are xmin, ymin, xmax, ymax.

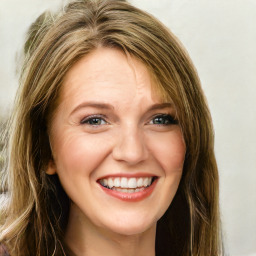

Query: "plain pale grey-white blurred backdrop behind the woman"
<box><xmin>0</xmin><ymin>0</ymin><xmax>256</xmax><ymax>256</ymax></box>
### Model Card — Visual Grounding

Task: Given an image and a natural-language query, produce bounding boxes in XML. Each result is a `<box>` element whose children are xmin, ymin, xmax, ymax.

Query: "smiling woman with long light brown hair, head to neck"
<box><xmin>0</xmin><ymin>0</ymin><xmax>222</xmax><ymax>256</ymax></box>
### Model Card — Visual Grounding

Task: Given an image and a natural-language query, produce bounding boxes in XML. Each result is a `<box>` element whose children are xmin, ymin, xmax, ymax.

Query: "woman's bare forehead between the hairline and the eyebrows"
<box><xmin>61</xmin><ymin>48</ymin><xmax>162</xmax><ymax>102</ymax></box>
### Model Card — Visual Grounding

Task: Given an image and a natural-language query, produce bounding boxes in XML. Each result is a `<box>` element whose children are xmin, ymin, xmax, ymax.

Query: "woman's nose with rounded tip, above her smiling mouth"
<box><xmin>112</xmin><ymin>127</ymin><xmax>148</xmax><ymax>165</ymax></box>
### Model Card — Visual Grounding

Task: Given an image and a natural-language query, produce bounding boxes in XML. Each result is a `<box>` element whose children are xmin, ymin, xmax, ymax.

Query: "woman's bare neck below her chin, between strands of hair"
<box><xmin>65</xmin><ymin>204</ymin><xmax>156</xmax><ymax>256</ymax></box>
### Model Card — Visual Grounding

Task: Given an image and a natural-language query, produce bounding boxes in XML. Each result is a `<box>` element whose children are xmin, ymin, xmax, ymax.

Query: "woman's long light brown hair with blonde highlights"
<box><xmin>0</xmin><ymin>0</ymin><xmax>222</xmax><ymax>256</ymax></box>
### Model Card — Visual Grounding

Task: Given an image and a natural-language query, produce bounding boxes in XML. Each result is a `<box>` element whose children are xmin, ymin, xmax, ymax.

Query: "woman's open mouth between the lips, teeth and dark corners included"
<box><xmin>98</xmin><ymin>176</ymin><xmax>157</xmax><ymax>193</ymax></box>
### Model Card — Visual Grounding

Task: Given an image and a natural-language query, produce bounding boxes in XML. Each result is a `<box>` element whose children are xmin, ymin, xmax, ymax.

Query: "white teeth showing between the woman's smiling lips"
<box><xmin>100</xmin><ymin>177</ymin><xmax>152</xmax><ymax>190</ymax></box>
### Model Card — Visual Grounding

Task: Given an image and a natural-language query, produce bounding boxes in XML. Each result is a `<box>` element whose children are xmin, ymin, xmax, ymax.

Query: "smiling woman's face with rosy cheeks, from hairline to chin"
<box><xmin>47</xmin><ymin>48</ymin><xmax>186</xmax><ymax>235</ymax></box>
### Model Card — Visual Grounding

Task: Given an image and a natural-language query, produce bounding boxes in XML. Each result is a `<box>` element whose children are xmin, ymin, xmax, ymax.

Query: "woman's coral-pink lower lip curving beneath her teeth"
<box><xmin>100</xmin><ymin>180</ymin><xmax>157</xmax><ymax>202</ymax></box>
